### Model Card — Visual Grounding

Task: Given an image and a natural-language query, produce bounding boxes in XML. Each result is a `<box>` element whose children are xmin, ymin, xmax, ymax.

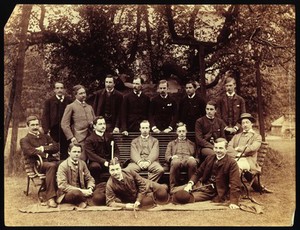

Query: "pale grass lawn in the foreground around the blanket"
<box><xmin>4</xmin><ymin>137</ymin><xmax>296</xmax><ymax>226</ymax></box>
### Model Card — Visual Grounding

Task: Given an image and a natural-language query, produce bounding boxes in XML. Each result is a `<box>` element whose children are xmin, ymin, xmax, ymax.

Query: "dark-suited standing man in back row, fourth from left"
<box><xmin>122</xmin><ymin>76</ymin><xmax>150</xmax><ymax>136</ymax></box>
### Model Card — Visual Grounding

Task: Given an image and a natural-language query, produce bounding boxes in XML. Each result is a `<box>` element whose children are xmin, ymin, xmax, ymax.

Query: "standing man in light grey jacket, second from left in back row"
<box><xmin>61</xmin><ymin>85</ymin><xmax>95</xmax><ymax>161</ymax></box>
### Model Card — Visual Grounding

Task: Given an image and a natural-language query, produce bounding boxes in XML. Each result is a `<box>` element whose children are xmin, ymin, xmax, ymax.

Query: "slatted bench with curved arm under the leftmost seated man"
<box><xmin>23</xmin><ymin>154</ymin><xmax>46</xmax><ymax>202</ymax></box>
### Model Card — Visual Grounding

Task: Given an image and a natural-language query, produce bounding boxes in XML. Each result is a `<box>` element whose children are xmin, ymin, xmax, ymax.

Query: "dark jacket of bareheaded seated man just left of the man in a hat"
<box><xmin>195</xmin><ymin>115</ymin><xmax>226</xmax><ymax>149</ymax></box>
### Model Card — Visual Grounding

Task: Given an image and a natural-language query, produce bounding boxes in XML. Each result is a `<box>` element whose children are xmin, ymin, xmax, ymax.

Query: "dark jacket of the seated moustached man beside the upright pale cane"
<box><xmin>84</xmin><ymin>131</ymin><xmax>120</xmax><ymax>165</ymax></box>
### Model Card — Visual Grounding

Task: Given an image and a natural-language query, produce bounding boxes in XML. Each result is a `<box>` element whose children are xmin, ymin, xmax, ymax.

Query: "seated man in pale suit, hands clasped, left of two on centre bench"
<box><xmin>126</xmin><ymin>120</ymin><xmax>164</xmax><ymax>182</ymax></box>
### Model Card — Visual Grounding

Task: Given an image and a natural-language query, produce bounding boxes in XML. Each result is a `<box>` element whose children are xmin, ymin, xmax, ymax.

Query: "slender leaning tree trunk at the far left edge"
<box><xmin>7</xmin><ymin>5</ymin><xmax>32</xmax><ymax>175</ymax></box>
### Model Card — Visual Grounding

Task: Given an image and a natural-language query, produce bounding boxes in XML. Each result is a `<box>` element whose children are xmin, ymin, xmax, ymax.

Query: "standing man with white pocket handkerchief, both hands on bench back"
<box><xmin>150</xmin><ymin>80</ymin><xmax>177</xmax><ymax>133</ymax></box>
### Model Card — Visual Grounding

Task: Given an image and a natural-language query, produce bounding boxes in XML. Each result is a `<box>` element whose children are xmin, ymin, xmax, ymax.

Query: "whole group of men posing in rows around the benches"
<box><xmin>20</xmin><ymin>72</ymin><xmax>270</xmax><ymax>209</ymax></box>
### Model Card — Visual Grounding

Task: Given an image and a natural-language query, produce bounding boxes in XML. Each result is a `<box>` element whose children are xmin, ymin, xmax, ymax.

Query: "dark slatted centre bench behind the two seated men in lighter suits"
<box><xmin>113</xmin><ymin>132</ymin><xmax>195</xmax><ymax>181</ymax></box>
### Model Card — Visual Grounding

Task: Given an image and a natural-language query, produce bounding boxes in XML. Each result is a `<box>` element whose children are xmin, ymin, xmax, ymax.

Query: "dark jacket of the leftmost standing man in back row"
<box><xmin>41</xmin><ymin>95</ymin><xmax>73</xmax><ymax>142</ymax></box>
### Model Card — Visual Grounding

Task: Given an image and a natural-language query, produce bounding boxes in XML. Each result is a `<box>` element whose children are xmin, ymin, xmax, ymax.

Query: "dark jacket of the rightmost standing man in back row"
<box><xmin>217</xmin><ymin>93</ymin><xmax>246</xmax><ymax>127</ymax></box>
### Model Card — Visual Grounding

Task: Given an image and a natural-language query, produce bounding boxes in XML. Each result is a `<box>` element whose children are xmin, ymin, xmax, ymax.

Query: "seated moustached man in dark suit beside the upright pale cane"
<box><xmin>84</xmin><ymin>116</ymin><xmax>119</xmax><ymax>184</ymax></box>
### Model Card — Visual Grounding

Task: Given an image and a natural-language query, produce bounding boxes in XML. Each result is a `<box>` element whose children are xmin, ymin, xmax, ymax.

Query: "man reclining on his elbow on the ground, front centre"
<box><xmin>105</xmin><ymin>158</ymin><xmax>168</xmax><ymax>209</ymax></box>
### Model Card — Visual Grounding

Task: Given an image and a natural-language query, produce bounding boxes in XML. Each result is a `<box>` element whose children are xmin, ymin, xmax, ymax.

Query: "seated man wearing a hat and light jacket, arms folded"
<box><xmin>228</xmin><ymin>113</ymin><xmax>272</xmax><ymax>193</ymax></box>
